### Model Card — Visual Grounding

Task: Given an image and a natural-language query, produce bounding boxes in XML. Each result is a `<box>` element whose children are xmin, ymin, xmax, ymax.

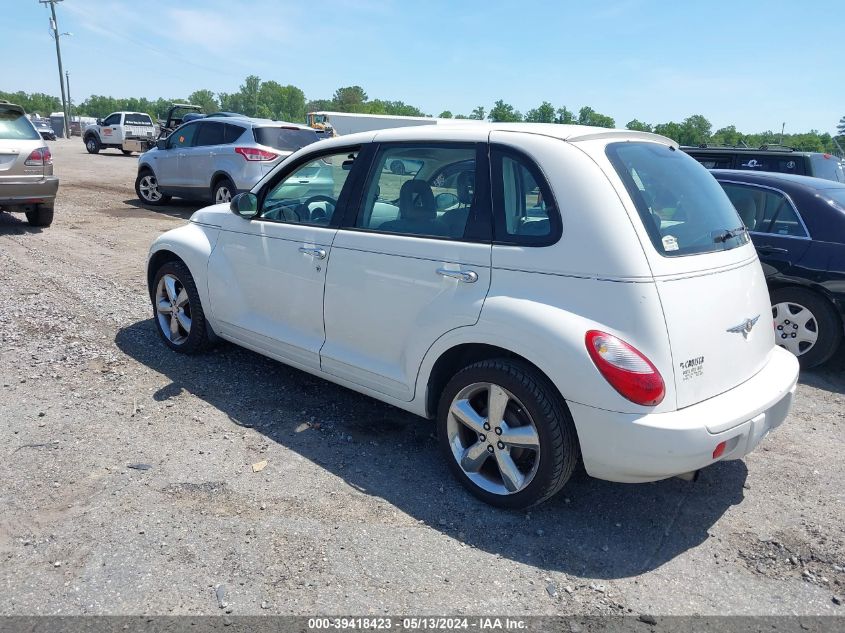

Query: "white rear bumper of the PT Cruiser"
<box><xmin>569</xmin><ymin>347</ymin><xmax>798</xmax><ymax>483</ymax></box>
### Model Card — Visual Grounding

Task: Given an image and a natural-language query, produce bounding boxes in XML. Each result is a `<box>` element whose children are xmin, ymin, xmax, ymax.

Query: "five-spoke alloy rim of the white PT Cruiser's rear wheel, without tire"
<box><xmin>446</xmin><ymin>383</ymin><xmax>540</xmax><ymax>495</ymax></box>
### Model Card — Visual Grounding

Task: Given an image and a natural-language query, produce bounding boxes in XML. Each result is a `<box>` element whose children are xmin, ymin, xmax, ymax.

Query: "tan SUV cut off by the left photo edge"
<box><xmin>0</xmin><ymin>99</ymin><xmax>59</xmax><ymax>226</ymax></box>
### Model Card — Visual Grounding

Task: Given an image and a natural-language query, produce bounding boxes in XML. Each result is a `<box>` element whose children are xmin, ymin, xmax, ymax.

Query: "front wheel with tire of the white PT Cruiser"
<box><xmin>152</xmin><ymin>261</ymin><xmax>211</xmax><ymax>354</ymax></box>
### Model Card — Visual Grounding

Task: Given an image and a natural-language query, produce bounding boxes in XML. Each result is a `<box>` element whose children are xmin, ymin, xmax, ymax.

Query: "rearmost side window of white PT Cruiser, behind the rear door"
<box><xmin>492</xmin><ymin>149</ymin><xmax>561</xmax><ymax>246</ymax></box>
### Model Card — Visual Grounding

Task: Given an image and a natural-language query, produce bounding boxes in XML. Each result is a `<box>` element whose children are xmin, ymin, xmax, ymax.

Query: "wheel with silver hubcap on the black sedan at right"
<box><xmin>771</xmin><ymin>288</ymin><xmax>842</xmax><ymax>369</ymax></box>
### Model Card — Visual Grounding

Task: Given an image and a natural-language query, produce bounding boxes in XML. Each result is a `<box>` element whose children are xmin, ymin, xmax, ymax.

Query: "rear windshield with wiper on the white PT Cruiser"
<box><xmin>607</xmin><ymin>142</ymin><xmax>749</xmax><ymax>257</ymax></box>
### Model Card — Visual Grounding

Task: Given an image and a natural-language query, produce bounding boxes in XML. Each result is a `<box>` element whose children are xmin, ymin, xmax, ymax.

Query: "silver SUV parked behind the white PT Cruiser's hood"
<box><xmin>135</xmin><ymin>116</ymin><xmax>318</xmax><ymax>205</ymax></box>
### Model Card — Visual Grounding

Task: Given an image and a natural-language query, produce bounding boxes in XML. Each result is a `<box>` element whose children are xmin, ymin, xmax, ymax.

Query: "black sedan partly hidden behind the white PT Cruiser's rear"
<box><xmin>713</xmin><ymin>169</ymin><xmax>845</xmax><ymax>367</ymax></box>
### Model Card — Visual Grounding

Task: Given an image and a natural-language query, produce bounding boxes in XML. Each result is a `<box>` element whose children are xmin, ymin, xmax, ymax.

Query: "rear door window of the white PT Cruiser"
<box><xmin>355</xmin><ymin>144</ymin><xmax>477</xmax><ymax>239</ymax></box>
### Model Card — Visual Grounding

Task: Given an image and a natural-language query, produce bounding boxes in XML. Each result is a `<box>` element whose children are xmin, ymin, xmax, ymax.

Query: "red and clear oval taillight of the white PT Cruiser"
<box><xmin>584</xmin><ymin>330</ymin><xmax>666</xmax><ymax>406</ymax></box>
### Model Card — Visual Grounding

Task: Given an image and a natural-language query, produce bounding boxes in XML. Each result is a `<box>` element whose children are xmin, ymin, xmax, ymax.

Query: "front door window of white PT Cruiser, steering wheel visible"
<box><xmin>258</xmin><ymin>150</ymin><xmax>357</xmax><ymax>226</ymax></box>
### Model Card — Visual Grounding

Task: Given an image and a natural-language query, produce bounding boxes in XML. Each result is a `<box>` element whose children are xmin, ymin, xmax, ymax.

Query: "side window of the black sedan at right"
<box><xmin>719</xmin><ymin>182</ymin><xmax>808</xmax><ymax>237</ymax></box>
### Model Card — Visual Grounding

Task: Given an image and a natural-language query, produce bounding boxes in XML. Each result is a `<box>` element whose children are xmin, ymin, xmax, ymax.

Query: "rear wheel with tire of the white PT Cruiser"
<box><xmin>437</xmin><ymin>358</ymin><xmax>579</xmax><ymax>509</ymax></box>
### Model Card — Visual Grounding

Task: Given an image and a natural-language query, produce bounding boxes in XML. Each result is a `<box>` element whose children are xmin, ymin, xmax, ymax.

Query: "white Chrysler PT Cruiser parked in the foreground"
<box><xmin>147</xmin><ymin>123</ymin><xmax>798</xmax><ymax>508</ymax></box>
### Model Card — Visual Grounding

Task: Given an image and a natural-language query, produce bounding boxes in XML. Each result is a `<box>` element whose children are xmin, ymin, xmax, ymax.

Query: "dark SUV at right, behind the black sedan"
<box><xmin>681</xmin><ymin>145</ymin><xmax>845</xmax><ymax>182</ymax></box>
